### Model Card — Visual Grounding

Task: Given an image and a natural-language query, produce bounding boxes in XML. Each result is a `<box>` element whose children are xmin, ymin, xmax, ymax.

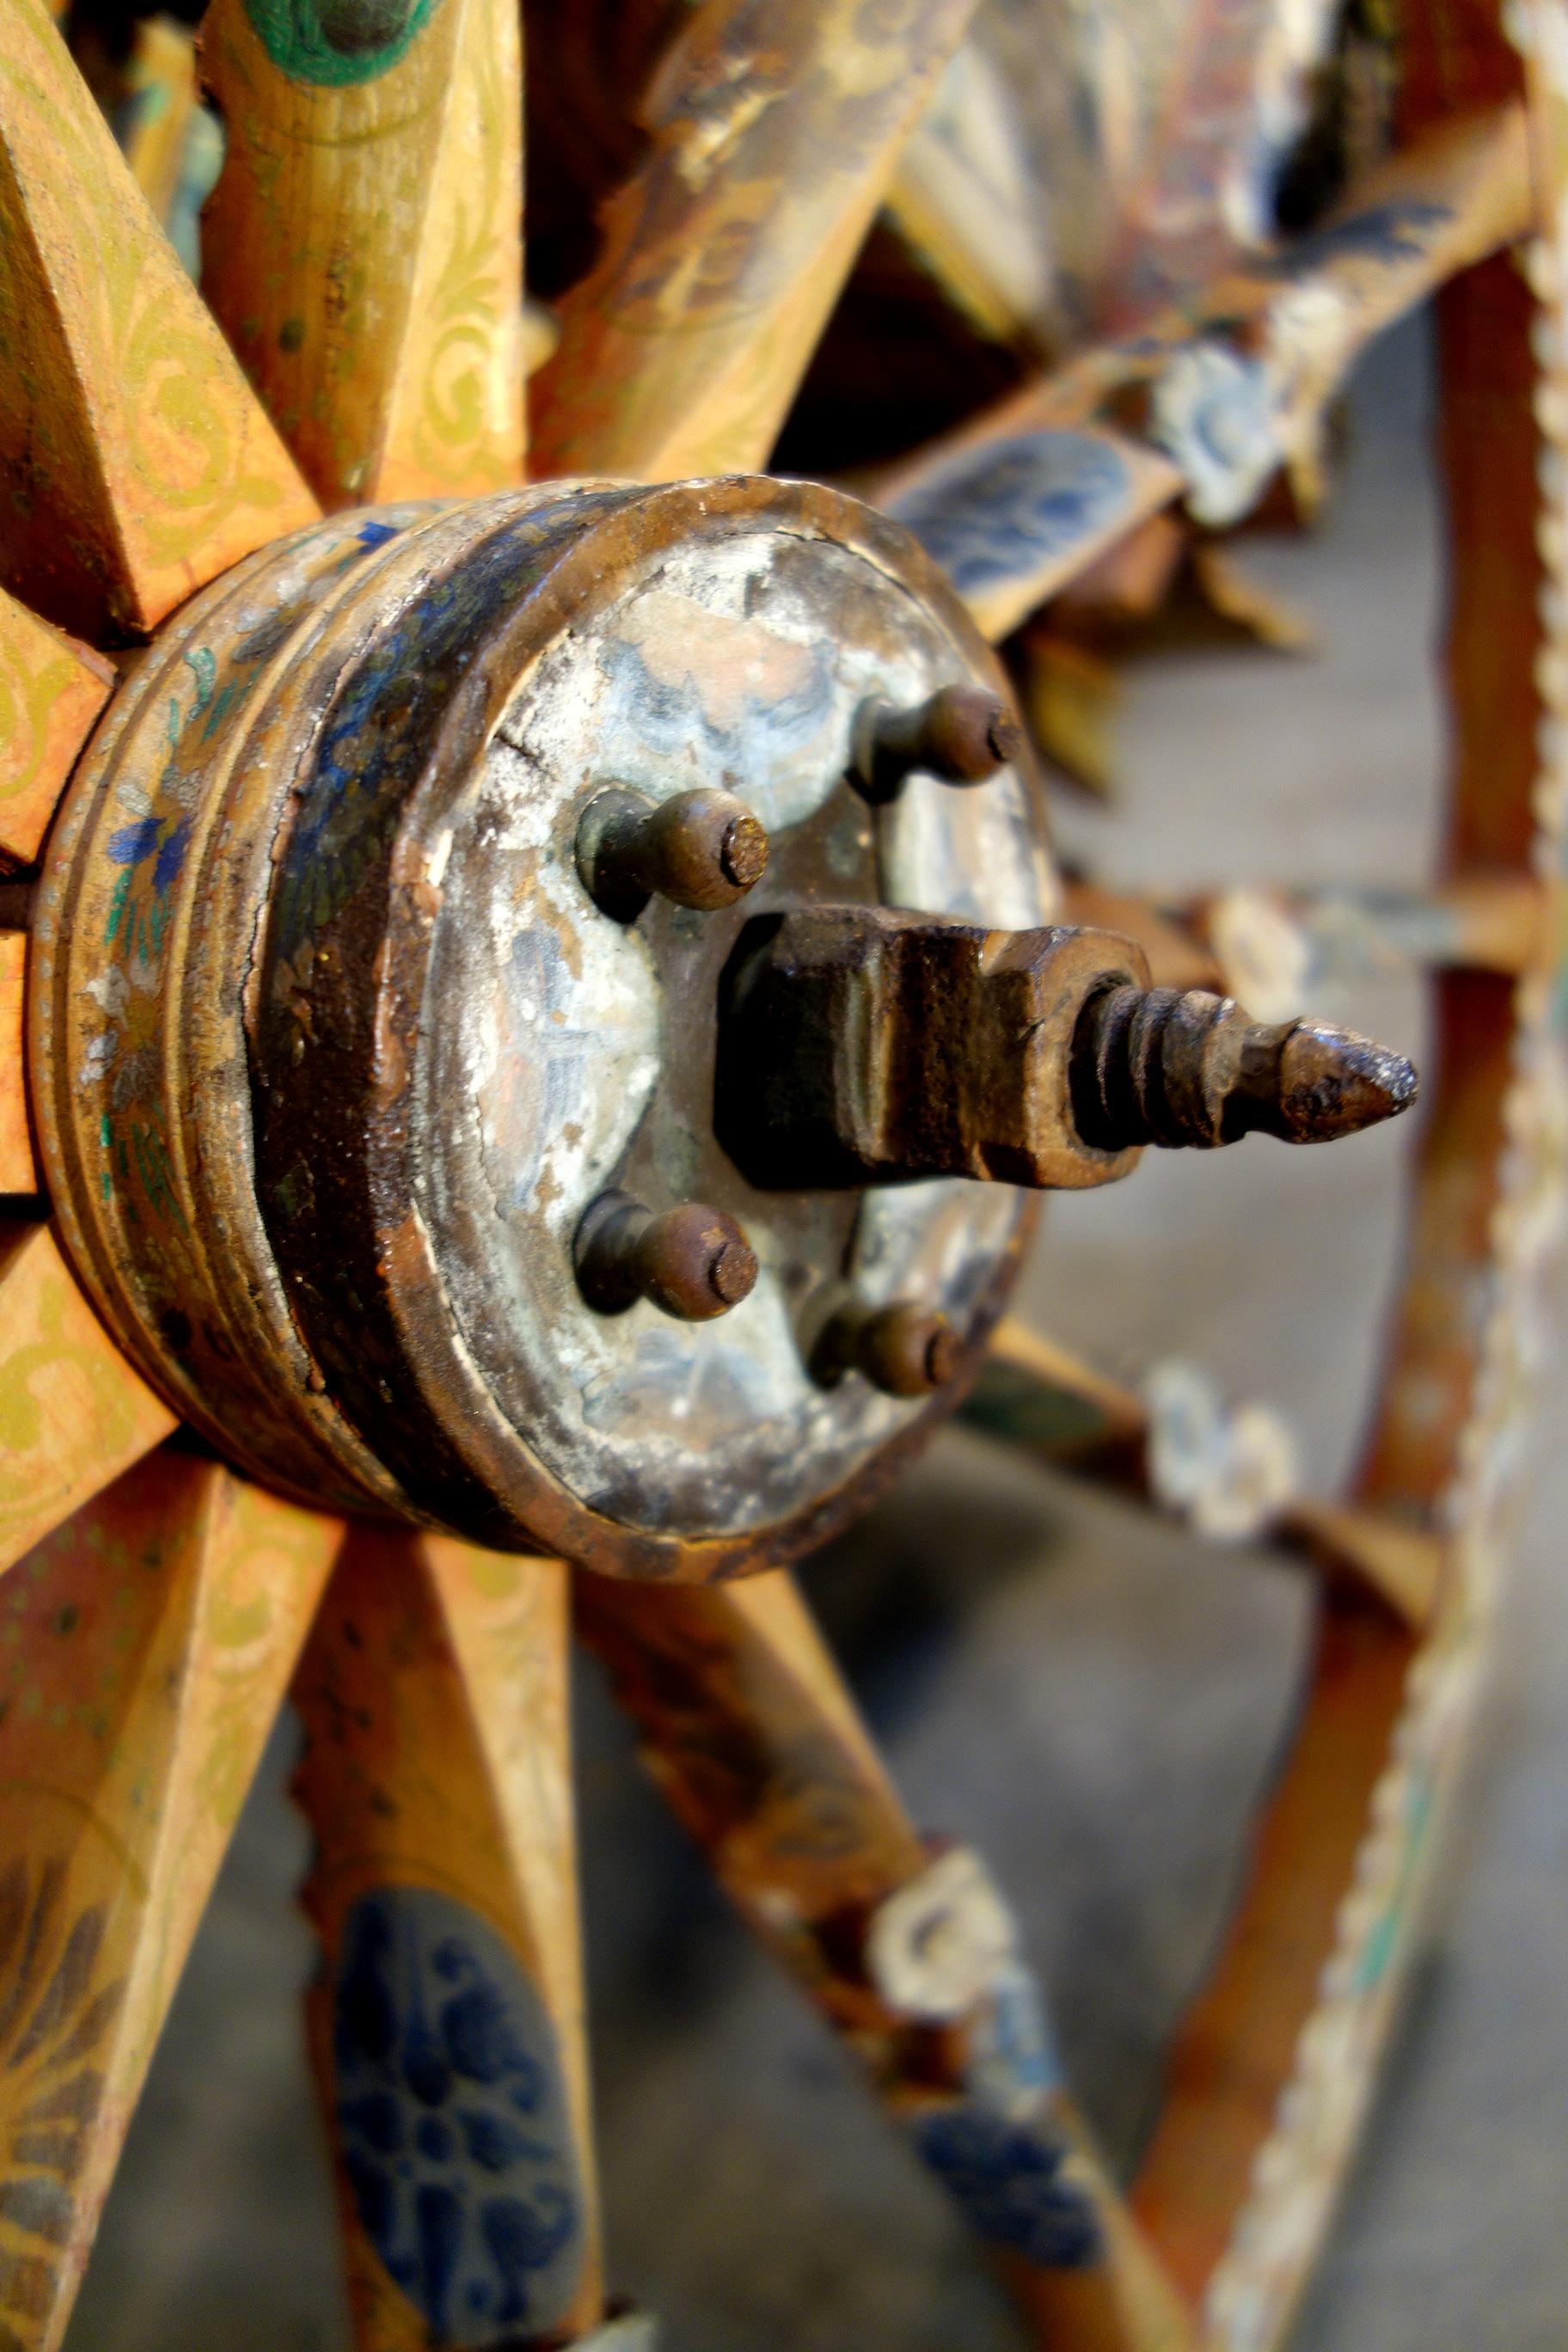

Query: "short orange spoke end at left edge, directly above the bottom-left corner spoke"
<box><xmin>0</xmin><ymin>1225</ymin><xmax>174</xmax><ymax>1569</ymax></box>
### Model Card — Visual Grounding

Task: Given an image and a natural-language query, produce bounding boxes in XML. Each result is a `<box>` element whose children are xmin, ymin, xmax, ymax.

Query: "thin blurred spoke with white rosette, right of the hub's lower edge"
<box><xmin>959</xmin><ymin>1322</ymin><xmax>1446</xmax><ymax>1626</ymax></box>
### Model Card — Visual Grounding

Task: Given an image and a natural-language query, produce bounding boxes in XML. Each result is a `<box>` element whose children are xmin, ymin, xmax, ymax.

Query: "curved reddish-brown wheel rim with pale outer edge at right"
<box><xmin>1185</xmin><ymin>4</ymin><xmax>1565</xmax><ymax>2314</ymax></box>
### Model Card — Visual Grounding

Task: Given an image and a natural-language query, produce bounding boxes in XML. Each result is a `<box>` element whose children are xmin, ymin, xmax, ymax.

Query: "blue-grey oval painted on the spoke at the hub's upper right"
<box><xmin>893</xmin><ymin>431</ymin><xmax>1129</xmax><ymax>595</ymax></box>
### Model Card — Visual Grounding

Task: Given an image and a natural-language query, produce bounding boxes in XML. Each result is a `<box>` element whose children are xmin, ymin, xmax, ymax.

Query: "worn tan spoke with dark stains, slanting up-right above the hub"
<box><xmin>531</xmin><ymin>0</ymin><xmax>973</xmax><ymax>480</ymax></box>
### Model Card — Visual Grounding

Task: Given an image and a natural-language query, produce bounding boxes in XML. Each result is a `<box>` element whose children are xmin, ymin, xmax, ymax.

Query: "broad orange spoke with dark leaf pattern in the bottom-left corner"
<box><xmin>0</xmin><ymin>1451</ymin><xmax>339</xmax><ymax>2352</ymax></box>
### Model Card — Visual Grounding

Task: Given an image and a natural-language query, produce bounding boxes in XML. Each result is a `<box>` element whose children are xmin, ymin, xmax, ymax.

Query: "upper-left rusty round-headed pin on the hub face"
<box><xmin>576</xmin><ymin>786</ymin><xmax>769</xmax><ymax>922</ymax></box>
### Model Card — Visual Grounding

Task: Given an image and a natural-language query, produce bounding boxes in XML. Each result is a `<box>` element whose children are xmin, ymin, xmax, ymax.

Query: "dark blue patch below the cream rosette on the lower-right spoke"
<box><xmin>915</xmin><ymin>2105</ymin><xmax>1105</xmax><ymax>2269</ymax></box>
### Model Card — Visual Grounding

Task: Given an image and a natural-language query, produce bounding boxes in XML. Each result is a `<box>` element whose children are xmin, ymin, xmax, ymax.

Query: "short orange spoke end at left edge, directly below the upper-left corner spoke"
<box><xmin>0</xmin><ymin>595</ymin><xmax>115</xmax><ymax>866</ymax></box>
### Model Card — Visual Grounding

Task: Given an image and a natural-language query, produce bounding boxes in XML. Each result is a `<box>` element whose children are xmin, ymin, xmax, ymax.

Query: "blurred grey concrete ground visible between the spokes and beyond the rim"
<box><xmin>68</xmin><ymin>317</ymin><xmax>1568</xmax><ymax>2352</ymax></box>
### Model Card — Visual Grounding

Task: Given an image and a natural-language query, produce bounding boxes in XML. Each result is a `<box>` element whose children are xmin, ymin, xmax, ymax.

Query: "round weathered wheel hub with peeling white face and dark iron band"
<box><xmin>35</xmin><ymin>480</ymin><xmax>1053</xmax><ymax>1576</ymax></box>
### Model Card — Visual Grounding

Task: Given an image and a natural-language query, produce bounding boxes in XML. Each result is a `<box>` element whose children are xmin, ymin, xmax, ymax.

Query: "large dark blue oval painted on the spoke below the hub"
<box><xmin>332</xmin><ymin>1886</ymin><xmax>583</xmax><ymax>2352</ymax></box>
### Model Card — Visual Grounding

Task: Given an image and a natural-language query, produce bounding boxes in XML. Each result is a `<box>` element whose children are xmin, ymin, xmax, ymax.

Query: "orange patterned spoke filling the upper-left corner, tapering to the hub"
<box><xmin>0</xmin><ymin>0</ymin><xmax>315</xmax><ymax>637</ymax></box>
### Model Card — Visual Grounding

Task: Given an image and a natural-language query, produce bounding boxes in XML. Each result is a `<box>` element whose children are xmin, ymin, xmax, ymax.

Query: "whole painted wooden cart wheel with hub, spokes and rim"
<box><xmin>0</xmin><ymin>0</ymin><xmax>1568</xmax><ymax>2352</ymax></box>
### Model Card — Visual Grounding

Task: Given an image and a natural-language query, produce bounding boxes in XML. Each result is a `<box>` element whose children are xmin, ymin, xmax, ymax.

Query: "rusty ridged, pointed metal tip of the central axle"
<box><xmin>1072</xmin><ymin>988</ymin><xmax>1418</xmax><ymax>1153</ymax></box>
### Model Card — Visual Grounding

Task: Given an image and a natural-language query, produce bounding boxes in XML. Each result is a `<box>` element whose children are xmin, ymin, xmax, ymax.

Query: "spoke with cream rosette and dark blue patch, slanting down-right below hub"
<box><xmin>576</xmin><ymin>1571</ymin><xmax>1190</xmax><ymax>2352</ymax></box>
